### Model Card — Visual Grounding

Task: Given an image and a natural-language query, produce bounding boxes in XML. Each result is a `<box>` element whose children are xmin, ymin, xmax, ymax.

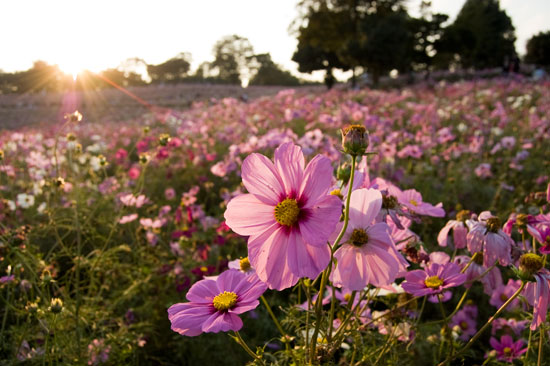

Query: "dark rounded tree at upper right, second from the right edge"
<box><xmin>439</xmin><ymin>0</ymin><xmax>516</xmax><ymax>69</ymax></box>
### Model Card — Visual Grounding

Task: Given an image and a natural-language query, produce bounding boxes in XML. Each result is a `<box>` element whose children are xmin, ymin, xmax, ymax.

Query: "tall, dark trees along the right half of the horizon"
<box><xmin>292</xmin><ymin>0</ymin><xmax>550</xmax><ymax>87</ymax></box>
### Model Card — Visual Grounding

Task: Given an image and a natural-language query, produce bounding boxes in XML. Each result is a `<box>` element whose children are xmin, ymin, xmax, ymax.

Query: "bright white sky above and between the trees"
<box><xmin>0</xmin><ymin>0</ymin><xmax>550</xmax><ymax>80</ymax></box>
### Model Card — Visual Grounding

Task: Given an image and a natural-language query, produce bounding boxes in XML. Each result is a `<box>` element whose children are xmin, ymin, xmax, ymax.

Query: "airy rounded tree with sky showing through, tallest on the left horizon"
<box><xmin>210</xmin><ymin>35</ymin><xmax>254</xmax><ymax>84</ymax></box>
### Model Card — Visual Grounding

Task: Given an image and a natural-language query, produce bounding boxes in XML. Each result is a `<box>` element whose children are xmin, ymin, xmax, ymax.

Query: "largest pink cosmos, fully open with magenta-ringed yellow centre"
<box><xmin>225</xmin><ymin>143</ymin><xmax>342</xmax><ymax>290</ymax></box>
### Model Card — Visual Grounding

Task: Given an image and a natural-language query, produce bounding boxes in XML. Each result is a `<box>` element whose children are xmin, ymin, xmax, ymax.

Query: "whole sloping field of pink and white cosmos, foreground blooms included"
<box><xmin>0</xmin><ymin>79</ymin><xmax>550</xmax><ymax>365</ymax></box>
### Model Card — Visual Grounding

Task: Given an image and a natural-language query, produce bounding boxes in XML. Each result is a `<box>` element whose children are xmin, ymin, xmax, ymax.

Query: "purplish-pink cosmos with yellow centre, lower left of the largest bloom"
<box><xmin>168</xmin><ymin>269</ymin><xmax>266</xmax><ymax>337</ymax></box>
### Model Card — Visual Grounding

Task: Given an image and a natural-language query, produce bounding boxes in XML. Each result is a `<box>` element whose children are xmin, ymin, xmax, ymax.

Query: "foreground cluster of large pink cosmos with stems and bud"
<box><xmin>168</xmin><ymin>137</ymin><xmax>550</xmax><ymax>364</ymax></box>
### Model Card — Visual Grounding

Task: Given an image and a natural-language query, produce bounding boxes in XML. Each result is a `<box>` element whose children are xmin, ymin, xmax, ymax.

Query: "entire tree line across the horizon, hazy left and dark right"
<box><xmin>0</xmin><ymin>0</ymin><xmax>550</xmax><ymax>94</ymax></box>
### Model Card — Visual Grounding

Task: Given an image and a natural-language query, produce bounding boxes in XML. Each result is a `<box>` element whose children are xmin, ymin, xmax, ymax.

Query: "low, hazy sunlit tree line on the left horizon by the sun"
<box><xmin>0</xmin><ymin>35</ymin><xmax>307</xmax><ymax>94</ymax></box>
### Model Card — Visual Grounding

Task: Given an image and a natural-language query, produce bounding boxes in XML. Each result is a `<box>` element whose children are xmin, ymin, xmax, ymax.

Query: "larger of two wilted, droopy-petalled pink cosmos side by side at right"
<box><xmin>466</xmin><ymin>211</ymin><xmax>514</xmax><ymax>267</ymax></box>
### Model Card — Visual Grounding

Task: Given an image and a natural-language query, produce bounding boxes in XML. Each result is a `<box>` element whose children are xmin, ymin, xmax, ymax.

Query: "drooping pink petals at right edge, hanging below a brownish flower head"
<box><xmin>523</xmin><ymin>268</ymin><xmax>550</xmax><ymax>330</ymax></box>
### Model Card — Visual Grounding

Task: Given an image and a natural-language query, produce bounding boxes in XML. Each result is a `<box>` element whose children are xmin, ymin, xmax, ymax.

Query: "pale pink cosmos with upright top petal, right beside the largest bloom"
<box><xmin>331</xmin><ymin>188</ymin><xmax>408</xmax><ymax>291</ymax></box>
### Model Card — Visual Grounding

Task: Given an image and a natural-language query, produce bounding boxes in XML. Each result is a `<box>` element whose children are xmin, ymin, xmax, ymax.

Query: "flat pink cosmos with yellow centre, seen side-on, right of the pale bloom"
<box><xmin>401</xmin><ymin>262</ymin><xmax>466</xmax><ymax>296</ymax></box>
